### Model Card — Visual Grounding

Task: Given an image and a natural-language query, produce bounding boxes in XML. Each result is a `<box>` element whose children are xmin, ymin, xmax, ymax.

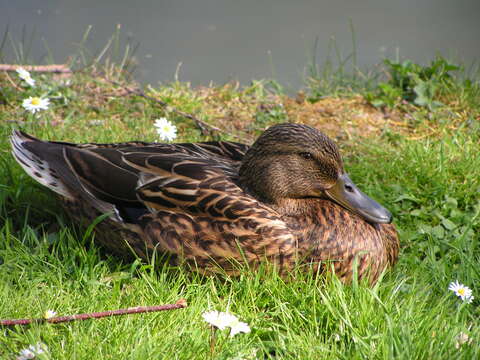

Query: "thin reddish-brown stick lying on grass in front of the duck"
<box><xmin>0</xmin><ymin>299</ymin><xmax>187</xmax><ymax>326</ymax></box>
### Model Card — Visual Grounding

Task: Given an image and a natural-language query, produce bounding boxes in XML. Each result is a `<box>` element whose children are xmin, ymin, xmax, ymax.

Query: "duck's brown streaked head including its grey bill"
<box><xmin>239</xmin><ymin>124</ymin><xmax>392</xmax><ymax>223</ymax></box>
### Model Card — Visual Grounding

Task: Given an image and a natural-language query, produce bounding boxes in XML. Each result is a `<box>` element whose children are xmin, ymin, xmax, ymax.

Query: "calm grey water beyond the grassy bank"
<box><xmin>0</xmin><ymin>0</ymin><xmax>480</xmax><ymax>89</ymax></box>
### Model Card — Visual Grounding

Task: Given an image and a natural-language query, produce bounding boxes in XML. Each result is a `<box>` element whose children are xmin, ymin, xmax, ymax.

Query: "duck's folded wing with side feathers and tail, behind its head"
<box><xmin>11</xmin><ymin>132</ymin><xmax>296</xmax><ymax>267</ymax></box>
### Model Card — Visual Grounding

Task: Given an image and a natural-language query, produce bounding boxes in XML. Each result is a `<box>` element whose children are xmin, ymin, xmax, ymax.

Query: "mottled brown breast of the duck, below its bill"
<box><xmin>285</xmin><ymin>200</ymin><xmax>399</xmax><ymax>282</ymax></box>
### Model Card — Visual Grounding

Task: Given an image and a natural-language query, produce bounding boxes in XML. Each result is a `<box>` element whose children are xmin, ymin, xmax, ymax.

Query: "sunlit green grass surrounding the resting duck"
<box><xmin>0</xmin><ymin>55</ymin><xmax>480</xmax><ymax>359</ymax></box>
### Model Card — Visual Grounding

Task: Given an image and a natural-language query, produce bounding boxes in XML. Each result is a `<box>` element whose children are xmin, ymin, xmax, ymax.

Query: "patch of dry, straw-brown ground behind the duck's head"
<box><xmin>196</xmin><ymin>85</ymin><xmax>408</xmax><ymax>143</ymax></box>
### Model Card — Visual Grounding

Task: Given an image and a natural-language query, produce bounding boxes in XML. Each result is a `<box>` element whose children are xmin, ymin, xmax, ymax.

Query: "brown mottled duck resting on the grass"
<box><xmin>11</xmin><ymin>123</ymin><xmax>399</xmax><ymax>283</ymax></box>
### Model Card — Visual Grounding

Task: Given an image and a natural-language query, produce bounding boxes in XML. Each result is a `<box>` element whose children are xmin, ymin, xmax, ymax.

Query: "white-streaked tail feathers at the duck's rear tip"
<box><xmin>10</xmin><ymin>130</ymin><xmax>73</xmax><ymax>199</ymax></box>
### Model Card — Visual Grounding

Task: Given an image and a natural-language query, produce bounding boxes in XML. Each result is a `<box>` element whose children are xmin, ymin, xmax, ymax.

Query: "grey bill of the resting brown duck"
<box><xmin>325</xmin><ymin>174</ymin><xmax>392</xmax><ymax>224</ymax></box>
